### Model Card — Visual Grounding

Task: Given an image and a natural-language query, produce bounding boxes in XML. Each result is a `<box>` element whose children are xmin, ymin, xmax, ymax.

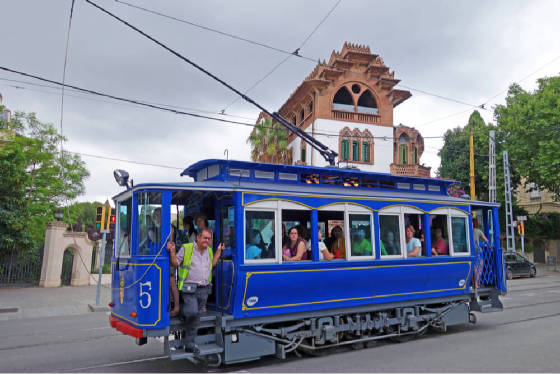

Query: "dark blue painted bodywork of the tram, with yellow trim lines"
<box><xmin>112</xmin><ymin>160</ymin><xmax>506</xmax><ymax>329</ymax></box>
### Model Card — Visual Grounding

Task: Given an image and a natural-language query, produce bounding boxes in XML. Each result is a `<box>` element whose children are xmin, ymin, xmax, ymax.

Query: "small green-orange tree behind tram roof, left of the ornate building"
<box><xmin>247</xmin><ymin>118</ymin><xmax>290</xmax><ymax>164</ymax></box>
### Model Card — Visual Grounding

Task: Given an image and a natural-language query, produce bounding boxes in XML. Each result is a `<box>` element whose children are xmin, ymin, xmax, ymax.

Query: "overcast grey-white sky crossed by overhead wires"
<box><xmin>0</xmin><ymin>0</ymin><xmax>560</xmax><ymax>205</ymax></box>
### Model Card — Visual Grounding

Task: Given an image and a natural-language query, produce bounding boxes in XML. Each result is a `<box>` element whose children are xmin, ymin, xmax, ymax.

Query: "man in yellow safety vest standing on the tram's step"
<box><xmin>167</xmin><ymin>228</ymin><xmax>224</xmax><ymax>354</ymax></box>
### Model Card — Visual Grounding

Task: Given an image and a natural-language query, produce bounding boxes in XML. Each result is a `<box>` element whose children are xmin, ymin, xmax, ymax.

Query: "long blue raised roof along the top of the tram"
<box><xmin>111</xmin><ymin>160</ymin><xmax>499</xmax><ymax>206</ymax></box>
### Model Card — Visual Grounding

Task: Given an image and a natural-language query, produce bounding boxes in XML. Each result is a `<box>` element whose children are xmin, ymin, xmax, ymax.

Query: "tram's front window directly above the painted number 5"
<box><xmin>138</xmin><ymin>192</ymin><xmax>161</xmax><ymax>255</ymax></box>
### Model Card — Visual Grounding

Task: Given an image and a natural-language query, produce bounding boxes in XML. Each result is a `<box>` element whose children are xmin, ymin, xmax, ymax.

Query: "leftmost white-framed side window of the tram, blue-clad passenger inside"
<box><xmin>245</xmin><ymin>211</ymin><xmax>276</xmax><ymax>260</ymax></box>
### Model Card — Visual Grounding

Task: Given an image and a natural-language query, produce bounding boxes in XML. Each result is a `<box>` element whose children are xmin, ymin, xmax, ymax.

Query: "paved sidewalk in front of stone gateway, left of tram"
<box><xmin>0</xmin><ymin>285</ymin><xmax>110</xmax><ymax>321</ymax></box>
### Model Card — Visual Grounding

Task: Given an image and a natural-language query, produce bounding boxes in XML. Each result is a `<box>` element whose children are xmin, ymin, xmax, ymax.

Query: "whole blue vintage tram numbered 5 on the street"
<box><xmin>110</xmin><ymin>160</ymin><xmax>506</xmax><ymax>365</ymax></box>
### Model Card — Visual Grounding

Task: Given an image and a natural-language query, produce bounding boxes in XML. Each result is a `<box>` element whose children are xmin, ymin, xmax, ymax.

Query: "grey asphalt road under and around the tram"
<box><xmin>0</xmin><ymin>273</ymin><xmax>560</xmax><ymax>373</ymax></box>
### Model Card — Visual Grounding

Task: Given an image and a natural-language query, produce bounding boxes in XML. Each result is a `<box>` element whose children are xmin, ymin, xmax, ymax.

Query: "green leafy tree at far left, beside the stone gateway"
<box><xmin>0</xmin><ymin>112</ymin><xmax>89</xmax><ymax>250</ymax></box>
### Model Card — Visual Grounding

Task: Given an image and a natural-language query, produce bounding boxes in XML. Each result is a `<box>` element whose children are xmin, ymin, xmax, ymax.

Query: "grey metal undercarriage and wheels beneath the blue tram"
<box><xmin>165</xmin><ymin>297</ymin><xmax>486</xmax><ymax>366</ymax></box>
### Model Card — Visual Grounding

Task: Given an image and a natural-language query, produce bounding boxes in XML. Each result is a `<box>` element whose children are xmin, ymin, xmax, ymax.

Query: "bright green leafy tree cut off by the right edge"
<box><xmin>494</xmin><ymin>76</ymin><xmax>560</xmax><ymax>200</ymax></box>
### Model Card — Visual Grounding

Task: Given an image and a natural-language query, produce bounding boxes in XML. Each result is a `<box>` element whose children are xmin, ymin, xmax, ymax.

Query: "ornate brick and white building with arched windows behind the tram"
<box><xmin>258</xmin><ymin>43</ymin><xmax>430</xmax><ymax>177</ymax></box>
